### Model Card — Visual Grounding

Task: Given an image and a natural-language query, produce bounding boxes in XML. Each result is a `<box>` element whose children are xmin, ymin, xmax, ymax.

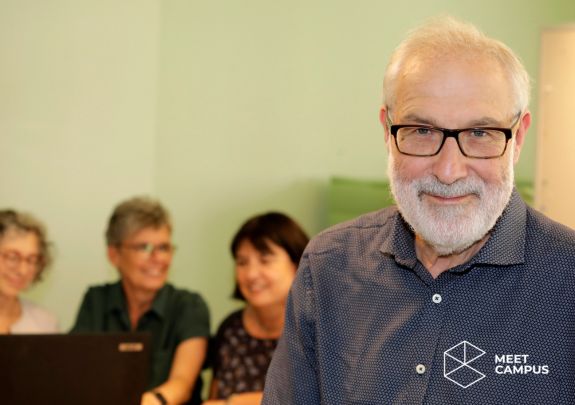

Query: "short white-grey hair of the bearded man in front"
<box><xmin>383</xmin><ymin>16</ymin><xmax>531</xmax><ymax>112</ymax></box>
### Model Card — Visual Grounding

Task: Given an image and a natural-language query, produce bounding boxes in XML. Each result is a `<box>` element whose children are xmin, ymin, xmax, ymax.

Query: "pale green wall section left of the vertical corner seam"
<box><xmin>0</xmin><ymin>0</ymin><xmax>160</xmax><ymax>329</ymax></box>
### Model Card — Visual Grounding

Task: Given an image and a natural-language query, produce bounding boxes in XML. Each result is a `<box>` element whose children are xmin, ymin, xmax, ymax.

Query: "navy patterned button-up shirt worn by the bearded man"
<box><xmin>263</xmin><ymin>191</ymin><xmax>575</xmax><ymax>405</ymax></box>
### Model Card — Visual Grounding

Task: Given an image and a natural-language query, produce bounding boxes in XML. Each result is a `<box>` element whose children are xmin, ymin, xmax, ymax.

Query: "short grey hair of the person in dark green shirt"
<box><xmin>106</xmin><ymin>197</ymin><xmax>172</xmax><ymax>246</ymax></box>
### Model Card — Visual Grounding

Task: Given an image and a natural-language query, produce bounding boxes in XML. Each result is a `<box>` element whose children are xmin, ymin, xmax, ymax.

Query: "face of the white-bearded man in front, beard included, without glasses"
<box><xmin>382</xmin><ymin>58</ymin><xmax>529</xmax><ymax>255</ymax></box>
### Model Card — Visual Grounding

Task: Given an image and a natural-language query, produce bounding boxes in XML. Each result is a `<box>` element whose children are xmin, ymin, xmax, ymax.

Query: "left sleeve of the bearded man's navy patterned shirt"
<box><xmin>262</xmin><ymin>255</ymin><xmax>320</xmax><ymax>405</ymax></box>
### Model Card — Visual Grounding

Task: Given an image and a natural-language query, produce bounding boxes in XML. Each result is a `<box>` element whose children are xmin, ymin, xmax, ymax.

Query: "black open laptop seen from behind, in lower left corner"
<box><xmin>0</xmin><ymin>333</ymin><xmax>150</xmax><ymax>405</ymax></box>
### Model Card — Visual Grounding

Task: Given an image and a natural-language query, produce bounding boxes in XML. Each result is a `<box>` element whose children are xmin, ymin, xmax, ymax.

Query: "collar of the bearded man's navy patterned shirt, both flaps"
<box><xmin>380</xmin><ymin>185</ymin><xmax>527</xmax><ymax>270</ymax></box>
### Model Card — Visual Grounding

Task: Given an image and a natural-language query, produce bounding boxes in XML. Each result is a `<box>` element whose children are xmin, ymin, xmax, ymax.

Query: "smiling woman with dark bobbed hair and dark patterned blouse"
<box><xmin>205</xmin><ymin>212</ymin><xmax>309</xmax><ymax>405</ymax></box>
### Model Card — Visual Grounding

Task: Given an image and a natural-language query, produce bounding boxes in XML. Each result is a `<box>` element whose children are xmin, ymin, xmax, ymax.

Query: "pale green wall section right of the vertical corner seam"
<box><xmin>156</xmin><ymin>0</ymin><xmax>575</xmax><ymax>328</ymax></box>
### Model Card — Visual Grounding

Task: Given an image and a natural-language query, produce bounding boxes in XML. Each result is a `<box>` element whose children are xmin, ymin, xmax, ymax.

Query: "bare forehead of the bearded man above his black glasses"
<box><xmin>388</xmin><ymin>58</ymin><xmax>516</xmax><ymax>128</ymax></box>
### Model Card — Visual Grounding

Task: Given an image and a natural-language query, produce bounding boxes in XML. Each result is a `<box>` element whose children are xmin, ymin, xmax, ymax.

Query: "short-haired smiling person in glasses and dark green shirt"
<box><xmin>72</xmin><ymin>197</ymin><xmax>210</xmax><ymax>405</ymax></box>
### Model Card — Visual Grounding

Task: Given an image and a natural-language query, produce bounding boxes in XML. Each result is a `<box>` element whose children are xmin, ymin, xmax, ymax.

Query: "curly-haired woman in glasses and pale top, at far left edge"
<box><xmin>0</xmin><ymin>210</ymin><xmax>58</xmax><ymax>334</ymax></box>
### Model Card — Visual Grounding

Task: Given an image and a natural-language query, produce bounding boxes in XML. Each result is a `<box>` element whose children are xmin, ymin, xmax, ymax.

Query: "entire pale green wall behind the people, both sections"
<box><xmin>0</xmin><ymin>0</ymin><xmax>575</xmax><ymax>327</ymax></box>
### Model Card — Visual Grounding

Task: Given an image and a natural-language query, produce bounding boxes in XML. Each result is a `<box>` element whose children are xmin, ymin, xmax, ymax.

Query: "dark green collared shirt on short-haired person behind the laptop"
<box><xmin>71</xmin><ymin>282</ymin><xmax>210</xmax><ymax>404</ymax></box>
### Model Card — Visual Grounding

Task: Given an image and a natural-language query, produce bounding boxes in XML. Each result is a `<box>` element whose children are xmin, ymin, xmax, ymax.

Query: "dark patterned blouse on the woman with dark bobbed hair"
<box><xmin>213</xmin><ymin>310</ymin><xmax>277</xmax><ymax>399</ymax></box>
